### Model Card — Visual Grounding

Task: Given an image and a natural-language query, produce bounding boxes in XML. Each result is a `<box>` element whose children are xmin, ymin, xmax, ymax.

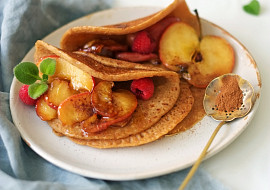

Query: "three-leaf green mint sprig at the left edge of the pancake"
<box><xmin>13</xmin><ymin>58</ymin><xmax>56</xmax><ymax>99</ymax></box>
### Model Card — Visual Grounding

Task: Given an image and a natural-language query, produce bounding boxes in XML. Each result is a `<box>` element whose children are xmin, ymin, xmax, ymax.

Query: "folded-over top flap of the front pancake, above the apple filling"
<box><xmin>35</xmin><ymin>40</ymin><xmax>179</xmax><ymax>81</ymax></box>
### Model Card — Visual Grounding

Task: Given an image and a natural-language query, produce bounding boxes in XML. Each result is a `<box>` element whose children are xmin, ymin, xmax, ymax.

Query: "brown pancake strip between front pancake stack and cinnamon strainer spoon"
<box><xmin>167</xmin><ymin>86</ymin><xmax>206</xmax><ymax>135</ymax></box>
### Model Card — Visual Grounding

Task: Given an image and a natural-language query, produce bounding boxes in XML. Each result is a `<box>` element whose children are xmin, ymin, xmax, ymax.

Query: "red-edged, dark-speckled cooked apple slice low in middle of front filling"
<box><xmin>57</xmin><ymin>92</ymin><xmax>94</xmax><ymax>125</ymax></box>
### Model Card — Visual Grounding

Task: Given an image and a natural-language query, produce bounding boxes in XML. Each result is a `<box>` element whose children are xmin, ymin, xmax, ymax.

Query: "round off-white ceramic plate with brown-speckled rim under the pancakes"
<box><xmin>10</xmin><ymin>7</ymin><xmax>261</xmax><ymax>180</ymax></box>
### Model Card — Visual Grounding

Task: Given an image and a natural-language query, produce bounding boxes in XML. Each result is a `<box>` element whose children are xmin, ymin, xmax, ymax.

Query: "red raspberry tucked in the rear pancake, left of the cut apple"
<box><xmin>132</xmin><ymin>31</ymin><xmax>154</xmax><ymax>54</ymax></box>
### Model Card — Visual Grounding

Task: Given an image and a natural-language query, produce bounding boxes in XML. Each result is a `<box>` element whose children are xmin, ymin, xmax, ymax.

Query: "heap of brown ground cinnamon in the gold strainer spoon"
<box><xmin>215</xmin><ymin>75</ymin><xmax>243</xmax><ymax>112</ymax></box>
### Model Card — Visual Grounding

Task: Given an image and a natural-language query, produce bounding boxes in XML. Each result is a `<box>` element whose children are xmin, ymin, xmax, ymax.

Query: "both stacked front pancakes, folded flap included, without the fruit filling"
<box><xmin>35</xmin><ymin>41</ymin><xmax>194</xmax><ymax>148</ymax></box>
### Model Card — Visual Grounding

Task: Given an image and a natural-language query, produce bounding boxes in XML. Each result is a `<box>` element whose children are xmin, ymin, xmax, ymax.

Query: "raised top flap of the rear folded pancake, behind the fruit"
<box><xmin>60</xmin><ymin>0</ymin><xmax>200</xmax><ymax>51</ymax></box>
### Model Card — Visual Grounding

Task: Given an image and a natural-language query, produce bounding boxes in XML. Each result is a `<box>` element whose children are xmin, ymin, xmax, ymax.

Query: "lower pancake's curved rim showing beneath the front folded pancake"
<box><xmin>70</xmin><ymin>83</ymin><xmax>194</xmax><ymax>148</ymax></box>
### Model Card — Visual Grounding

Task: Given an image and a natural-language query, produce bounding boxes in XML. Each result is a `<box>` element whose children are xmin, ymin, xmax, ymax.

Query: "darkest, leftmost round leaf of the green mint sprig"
<box><xmin>13</xmin><ymin>62</ymin><xmax>41</xmax><ymax>85</ymax></box>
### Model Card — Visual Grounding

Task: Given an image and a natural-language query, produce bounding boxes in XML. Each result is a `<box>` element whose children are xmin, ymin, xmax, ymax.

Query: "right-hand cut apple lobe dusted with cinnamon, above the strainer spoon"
<box><xmin>187</xmin><ymin>36</ymin><xmax>235</xmax><ymax>88</ymax></box>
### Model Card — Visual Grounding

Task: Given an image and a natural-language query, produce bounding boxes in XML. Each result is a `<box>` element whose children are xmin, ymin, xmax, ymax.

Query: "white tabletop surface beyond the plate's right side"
<box><xmin>114</xmin><ymin>0</ymin><xmax>270</xmax><ymax>190</ymax></box>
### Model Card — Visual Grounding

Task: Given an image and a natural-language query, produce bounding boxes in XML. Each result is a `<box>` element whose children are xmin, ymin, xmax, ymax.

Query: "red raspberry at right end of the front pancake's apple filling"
<box><xmin>130</xmin><ymin>78</ymin><xmax>154</xmax><ymax>100</ymax></box>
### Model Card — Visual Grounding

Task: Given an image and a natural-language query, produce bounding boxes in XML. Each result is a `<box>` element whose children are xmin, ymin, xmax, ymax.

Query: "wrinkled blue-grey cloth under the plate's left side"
<box><xmin>0</xmin><ymin>0</ymin><xmax>229</xmax><ymax>190</ymax></box>
